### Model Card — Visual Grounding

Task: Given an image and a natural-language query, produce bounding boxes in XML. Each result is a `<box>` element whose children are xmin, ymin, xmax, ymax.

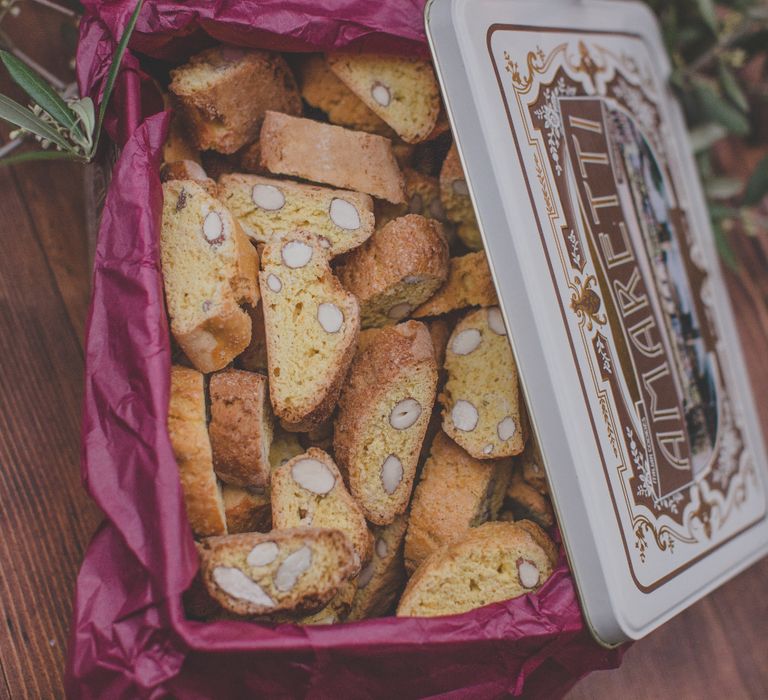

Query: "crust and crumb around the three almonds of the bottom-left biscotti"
<box><xmin>200</xmin><ymin>528</ymin><xmax>355</xmax><ymax>616</ymax></box>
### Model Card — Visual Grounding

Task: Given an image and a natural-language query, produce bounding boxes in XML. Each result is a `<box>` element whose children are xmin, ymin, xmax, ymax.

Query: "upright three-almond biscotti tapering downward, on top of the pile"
<box><xmin>260</xmin><ymin>232</ymin><xmax>360</xmax><ymax>432</ymax></box>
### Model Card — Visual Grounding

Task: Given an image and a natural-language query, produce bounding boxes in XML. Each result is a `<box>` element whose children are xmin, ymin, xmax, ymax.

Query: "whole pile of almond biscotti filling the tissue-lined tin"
<box><xmin>161</xmin><ymin>46</ymin><xmax>558</xmax><ymax>624</ymax></box>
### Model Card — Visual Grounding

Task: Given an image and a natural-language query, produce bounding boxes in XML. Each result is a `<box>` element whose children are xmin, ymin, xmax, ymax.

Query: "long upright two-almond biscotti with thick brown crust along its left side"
<box><xmin>334</xmin><ymin>321</ymin><xmax>437</xmax><ymax>525</ymax></box>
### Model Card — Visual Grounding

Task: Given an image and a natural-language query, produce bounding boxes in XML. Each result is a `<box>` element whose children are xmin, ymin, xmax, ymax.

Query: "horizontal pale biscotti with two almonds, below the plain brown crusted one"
<box><xmin>219</xmin><ymin>175</ymin><xmax>373</xmax><ymax>256</ymax></box>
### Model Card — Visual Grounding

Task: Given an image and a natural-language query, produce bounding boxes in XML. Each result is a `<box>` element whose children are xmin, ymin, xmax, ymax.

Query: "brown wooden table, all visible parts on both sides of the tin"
<box><xmin>0</xmin><ymin>8</ymin><xmax>768</xmax><ymax>700</ymax></box>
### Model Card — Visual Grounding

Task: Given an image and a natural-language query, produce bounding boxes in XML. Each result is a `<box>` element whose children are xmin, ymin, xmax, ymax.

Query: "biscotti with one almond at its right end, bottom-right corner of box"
<box><xmin>397</xmin><ymin>522</ymin><xmax>557</xmax><ymax>617</ymax></box>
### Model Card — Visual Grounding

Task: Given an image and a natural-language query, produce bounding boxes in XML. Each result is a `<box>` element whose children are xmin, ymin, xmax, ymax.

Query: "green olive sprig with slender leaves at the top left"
<box><xmin>0</xmin><ymin>0</ymin><xmax>144</xmax><ymax>166</ymax></box>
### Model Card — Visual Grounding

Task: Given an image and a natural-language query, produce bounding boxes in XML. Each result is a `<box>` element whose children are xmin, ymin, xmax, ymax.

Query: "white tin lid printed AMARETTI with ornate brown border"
<box><xmin>425</xmin><ymin>0</ymin><xmax>768</xmax><ymax>645</ymax></box>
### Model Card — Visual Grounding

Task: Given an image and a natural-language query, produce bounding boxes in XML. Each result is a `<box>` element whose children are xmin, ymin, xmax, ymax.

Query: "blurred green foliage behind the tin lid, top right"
<box><xmin>649</xmin><ymin>0</ymin><xmax>768</xmax><ymax>269</ymax></box>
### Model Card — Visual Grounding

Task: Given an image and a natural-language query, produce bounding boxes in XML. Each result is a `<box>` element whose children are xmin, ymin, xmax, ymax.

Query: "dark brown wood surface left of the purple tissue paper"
<box><xmin>0</xmin><ymin>4</ymin><xmax>100</xmax><ymax>698</ymax></box>
